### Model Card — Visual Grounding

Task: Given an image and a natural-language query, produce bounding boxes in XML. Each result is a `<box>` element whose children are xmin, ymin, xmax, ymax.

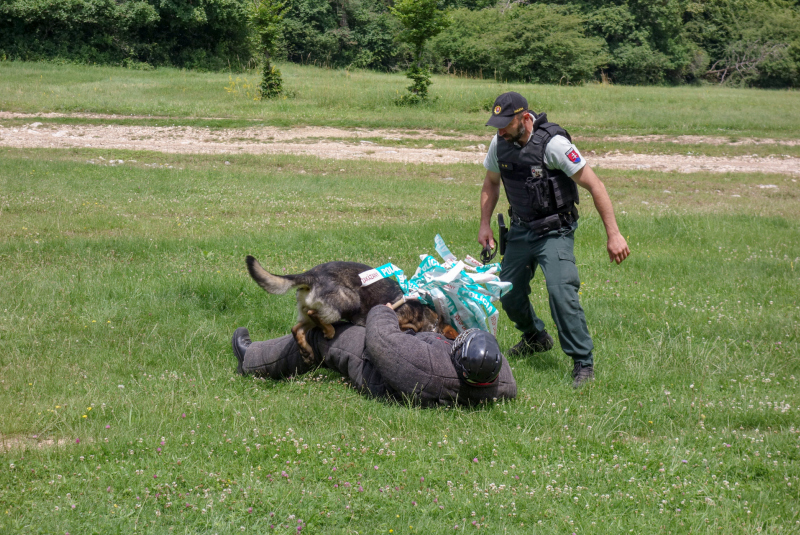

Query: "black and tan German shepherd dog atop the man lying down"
<box><xmin>246</xmin><ymin>255</ymin><xmax>456</xmax><ymax>364</ymax></box>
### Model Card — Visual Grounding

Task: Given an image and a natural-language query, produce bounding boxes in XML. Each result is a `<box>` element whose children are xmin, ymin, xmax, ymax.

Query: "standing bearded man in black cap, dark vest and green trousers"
<box><xmin>478</xmin><ymin>92</ymin><xmax>630</xmax><ymax>388</ymax></box>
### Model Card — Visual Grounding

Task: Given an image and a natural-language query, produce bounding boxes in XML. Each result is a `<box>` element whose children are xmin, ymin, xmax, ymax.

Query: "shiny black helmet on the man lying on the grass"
<box><xmin>450</xmin><ymin>329</ymin><xmax>503</xmax><ymax>386</ymax></box>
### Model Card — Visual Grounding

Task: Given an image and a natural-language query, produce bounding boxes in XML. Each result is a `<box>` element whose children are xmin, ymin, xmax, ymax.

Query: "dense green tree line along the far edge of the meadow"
<box><xmin>0</xmin><ymin>0</ymin><xmax>800</xmax><ymax>88</ymax></box>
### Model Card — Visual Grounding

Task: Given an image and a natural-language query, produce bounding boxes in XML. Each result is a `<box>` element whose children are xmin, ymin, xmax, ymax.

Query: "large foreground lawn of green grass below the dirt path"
<box><xmin>0</xmin><ymin>144</ymin><xmax>800</xmax><ymax>534</ymax></box>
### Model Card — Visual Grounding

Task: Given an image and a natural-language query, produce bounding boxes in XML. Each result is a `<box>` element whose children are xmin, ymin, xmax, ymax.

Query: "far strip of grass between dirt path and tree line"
<box><xmin>0</xmin><ymin>62</ymin><xmax>800</xmax><ymax>138</ymax></box>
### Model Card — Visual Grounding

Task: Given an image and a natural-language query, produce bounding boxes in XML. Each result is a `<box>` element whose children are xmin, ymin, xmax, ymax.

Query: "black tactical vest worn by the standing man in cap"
<box><xmin>497</xmin><ymin>113</ymin><xmax>579</xmax><ymax>221</ymax></box>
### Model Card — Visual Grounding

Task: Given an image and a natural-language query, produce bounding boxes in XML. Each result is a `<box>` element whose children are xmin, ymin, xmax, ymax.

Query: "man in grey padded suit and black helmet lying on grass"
<box><xmin>232</xmin><ymin>305</ymin><xmax>517</xmax><ymax>406</ymax></box>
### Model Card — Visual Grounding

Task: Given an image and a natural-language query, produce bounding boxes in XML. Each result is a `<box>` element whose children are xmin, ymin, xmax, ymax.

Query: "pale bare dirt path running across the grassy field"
<box><xmin>0</xmin><ymin>112</ymin><xmax>800</xmax><ymax>175</ymax></box>
